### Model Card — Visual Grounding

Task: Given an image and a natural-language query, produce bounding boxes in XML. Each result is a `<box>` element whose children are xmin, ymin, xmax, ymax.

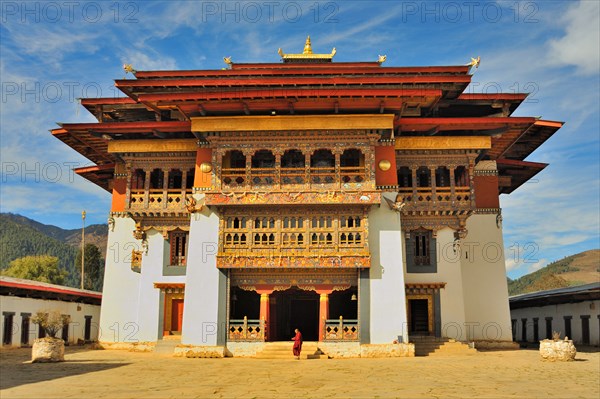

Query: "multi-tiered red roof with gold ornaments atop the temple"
<box><xmin>52</xmin><ymin>41</ymin><xmax>562</xmax><ymax>193</ymax></box>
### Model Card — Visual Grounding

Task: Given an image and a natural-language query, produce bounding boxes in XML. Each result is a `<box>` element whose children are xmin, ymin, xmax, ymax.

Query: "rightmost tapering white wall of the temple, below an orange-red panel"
<box><xmin>460</xmin><ymin>214</ymin><xmax>512</xmax><ymax>341</ymax></box>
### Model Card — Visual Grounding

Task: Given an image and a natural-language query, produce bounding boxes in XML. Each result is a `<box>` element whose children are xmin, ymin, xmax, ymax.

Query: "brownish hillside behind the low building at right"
<box><xmin>508</xmin><ymin>249</ymin><xmax>600</xmax><ymax>295</ymax></box>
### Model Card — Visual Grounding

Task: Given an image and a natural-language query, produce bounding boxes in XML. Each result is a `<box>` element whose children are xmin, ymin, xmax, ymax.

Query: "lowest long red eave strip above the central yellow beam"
<box><xmin>138</xmin><ymin>87</ymin><xmax>442</xmax><ymax>102</ymax></box>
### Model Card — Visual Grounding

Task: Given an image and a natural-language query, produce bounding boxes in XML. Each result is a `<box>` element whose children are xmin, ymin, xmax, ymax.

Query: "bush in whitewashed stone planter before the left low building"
<box><xmin>31</xmin><ymin>310</ymin><xmax>71</xmax><ymax>363</ymax></box>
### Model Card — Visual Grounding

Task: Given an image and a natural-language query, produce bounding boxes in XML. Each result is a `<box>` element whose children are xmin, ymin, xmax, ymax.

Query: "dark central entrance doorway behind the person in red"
<box><xmin>268</xmin><ymin>288</ymin><xmax>319</xmax><ymax>341</ymax></box>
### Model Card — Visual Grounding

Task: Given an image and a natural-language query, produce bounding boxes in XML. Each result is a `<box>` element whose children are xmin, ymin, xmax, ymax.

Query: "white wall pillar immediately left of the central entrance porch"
<box><xmin>181</xmin><ymin>203</ymin><xmax>220</xmax><ymax>346</ymax></box>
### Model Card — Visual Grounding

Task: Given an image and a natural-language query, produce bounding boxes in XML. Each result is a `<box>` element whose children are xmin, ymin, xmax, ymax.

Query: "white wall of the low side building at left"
<box><xmin>0</xmin><ymin>295</ymin><xmax>100</xmax><ymax>347</ymax></box>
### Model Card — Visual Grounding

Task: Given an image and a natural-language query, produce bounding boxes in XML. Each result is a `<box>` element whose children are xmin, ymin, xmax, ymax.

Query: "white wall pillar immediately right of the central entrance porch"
<box><xmin>369</xmin><ymin>193</ymin><xmax>408</xmax><ymax>344</ymax></box>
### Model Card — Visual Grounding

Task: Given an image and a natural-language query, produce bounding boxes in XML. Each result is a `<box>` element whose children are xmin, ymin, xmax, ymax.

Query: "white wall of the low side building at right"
<box><xmin>510</xmin><ymin>300</ymin><xmax>600</xmax><ymax>345</ymax></box>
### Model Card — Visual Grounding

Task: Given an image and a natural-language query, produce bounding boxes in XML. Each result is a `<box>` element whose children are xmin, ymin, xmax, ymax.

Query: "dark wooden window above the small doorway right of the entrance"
<box><xmin>406</xmin><ymin>229</ymin><xmax>437</xmax><ymax>273</ymax></box>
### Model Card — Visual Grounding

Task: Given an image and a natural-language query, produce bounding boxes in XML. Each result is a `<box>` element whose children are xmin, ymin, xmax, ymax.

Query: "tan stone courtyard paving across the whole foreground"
<box><xmin>0</xmin><ymin>348</ymin><xmax>600</xmax><ymax>399</ymax></box>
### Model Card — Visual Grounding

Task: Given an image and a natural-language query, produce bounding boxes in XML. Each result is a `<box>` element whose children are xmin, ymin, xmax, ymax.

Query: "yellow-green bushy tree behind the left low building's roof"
<box><xmin>2</xmin><ymin>255</ymin><xmax>67</xmax><ymax>285</ymax></box>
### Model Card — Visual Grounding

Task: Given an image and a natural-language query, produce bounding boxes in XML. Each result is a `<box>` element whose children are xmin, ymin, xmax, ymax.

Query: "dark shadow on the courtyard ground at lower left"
<box><xmin>0</xmin><ymin>349</ymin><xmax>129</xmax><ymax>390</ymax></box>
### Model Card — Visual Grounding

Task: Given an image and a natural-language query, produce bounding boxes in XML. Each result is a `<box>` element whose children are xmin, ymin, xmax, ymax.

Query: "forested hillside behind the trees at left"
<box><xmin>0</xmin><ymin>213</ymin><xmax>108</xmax><ymax>287</ymax></box>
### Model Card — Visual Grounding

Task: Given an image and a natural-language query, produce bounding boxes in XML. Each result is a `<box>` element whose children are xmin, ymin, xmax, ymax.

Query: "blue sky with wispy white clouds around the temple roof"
<box><xmin>0</xmin><ymin>0</ymin><xmax>600</xmax><ymax>277</ymax></box>
